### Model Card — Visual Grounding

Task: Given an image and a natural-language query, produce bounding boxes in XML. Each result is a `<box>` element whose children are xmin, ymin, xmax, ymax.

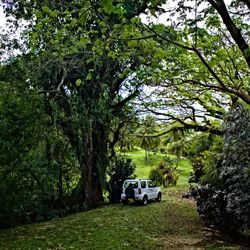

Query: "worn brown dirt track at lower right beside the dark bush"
<box><xmin>161</xmin><ymin>191</ymin><xmax>250</xmax><ymax>249</ymax></box>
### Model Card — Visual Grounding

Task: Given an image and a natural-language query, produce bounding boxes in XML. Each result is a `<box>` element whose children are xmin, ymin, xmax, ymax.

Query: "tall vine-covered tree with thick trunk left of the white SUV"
<box><xmin>1</xmin><ymin>0</ymin><xmax>166</xmax><ymax>208</ymax></box>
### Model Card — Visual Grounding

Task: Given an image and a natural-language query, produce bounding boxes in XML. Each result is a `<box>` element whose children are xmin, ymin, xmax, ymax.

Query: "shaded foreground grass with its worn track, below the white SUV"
<box><xmin>0</xmin><ymin>149</ymin><xmax>247</xmax><ymax>250</ymax></box>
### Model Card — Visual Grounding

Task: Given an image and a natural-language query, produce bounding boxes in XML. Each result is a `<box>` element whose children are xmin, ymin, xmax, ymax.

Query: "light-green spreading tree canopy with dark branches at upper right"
<box><xmin>140</xmin><ymin>1</ymin><xmax>250</xmax><ymax>134</ymax></box>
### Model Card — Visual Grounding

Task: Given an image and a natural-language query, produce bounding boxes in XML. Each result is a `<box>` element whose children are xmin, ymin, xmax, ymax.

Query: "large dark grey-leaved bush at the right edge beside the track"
<box><xmin>192</xmin><ymin>105</ymin><xmax>250</xmax><ymax>234</ymax></box>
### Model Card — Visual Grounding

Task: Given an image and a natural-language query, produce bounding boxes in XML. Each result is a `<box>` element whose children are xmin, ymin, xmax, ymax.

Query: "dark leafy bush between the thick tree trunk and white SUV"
<box><xmin>106</xmin><ymin>156</ymin><xmax>136</xmax><ymax>203</ymax></box>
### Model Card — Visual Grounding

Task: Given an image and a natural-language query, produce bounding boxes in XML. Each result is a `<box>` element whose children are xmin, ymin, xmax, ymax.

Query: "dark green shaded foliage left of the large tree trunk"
<box><xmin>0</xmin><ymin>63</ymin><xmax>79</xmax><ymax>227</ymax></box>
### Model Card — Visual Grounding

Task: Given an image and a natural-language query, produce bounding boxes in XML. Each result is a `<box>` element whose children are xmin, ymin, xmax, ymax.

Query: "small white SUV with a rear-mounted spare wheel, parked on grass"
<box><xmin>121</xmin><ymin>179</ymin><xmax>162</xmax><ymax>205</ymax></box>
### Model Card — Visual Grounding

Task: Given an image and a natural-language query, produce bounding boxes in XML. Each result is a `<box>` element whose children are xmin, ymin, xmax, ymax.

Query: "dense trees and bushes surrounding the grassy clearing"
<box><xmin>0</xmin><ymin>0</ymin><xmax>250</xmax><ymax>239</ymax></box>
